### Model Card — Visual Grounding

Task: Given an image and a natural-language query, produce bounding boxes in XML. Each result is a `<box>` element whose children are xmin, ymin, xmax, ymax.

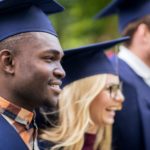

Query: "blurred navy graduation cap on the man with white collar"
<box><xmin>95</xmin><ymin>0</ymin><xmax>150</xmax><ymax>32</ymax></box>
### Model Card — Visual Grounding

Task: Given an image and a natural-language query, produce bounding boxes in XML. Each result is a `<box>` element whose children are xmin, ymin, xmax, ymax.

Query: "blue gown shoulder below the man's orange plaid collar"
<box><xmin>0</xmin><ymin>115</ymin><xmax>28</xmax><ymax>150</ymax></box>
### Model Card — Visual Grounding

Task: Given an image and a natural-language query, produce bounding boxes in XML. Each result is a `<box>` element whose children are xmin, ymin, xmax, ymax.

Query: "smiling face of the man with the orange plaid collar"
<box><xmin>14</xmin><ymin>32</ymin><xmax>65</xmax><ymax>108</ymax></box>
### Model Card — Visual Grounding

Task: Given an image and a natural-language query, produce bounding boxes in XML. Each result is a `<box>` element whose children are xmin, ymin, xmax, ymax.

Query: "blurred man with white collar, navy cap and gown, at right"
<box><xmin>97</xmin><ymin>0</ymin><xmax>150</xmax><ymax>150</ymax></box>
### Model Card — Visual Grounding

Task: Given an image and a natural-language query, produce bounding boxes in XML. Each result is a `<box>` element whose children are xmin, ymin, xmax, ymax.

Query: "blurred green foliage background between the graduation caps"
<box><xmin>50</xmin><ymin>0</ymin><xmax>119</xmax><ymax>49</ymax></box>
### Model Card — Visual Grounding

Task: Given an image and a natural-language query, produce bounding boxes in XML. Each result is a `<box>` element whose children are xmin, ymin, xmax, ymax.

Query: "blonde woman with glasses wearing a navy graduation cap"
<box><xmin>41</xmin><ymin>39</ymin><xmax>129</xmax><ymax>150</ymax></box>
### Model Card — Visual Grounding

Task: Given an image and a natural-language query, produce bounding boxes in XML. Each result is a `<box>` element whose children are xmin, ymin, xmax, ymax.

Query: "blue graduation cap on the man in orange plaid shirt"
<box><xmin>0</xmin><ymin>0</ymin><xmax>64</xmax><ymax>41</ymax></box>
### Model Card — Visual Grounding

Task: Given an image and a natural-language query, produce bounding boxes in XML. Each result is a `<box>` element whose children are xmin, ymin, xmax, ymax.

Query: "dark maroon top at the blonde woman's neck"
<box><xmin>82</xmin><ymin>133</ymin><xmax>96</xmax><ymax>150</ymax></box>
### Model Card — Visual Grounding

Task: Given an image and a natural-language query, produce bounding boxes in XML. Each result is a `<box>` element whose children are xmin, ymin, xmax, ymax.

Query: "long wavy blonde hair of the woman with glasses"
<box><xmin>41</xmin><ymin>74</ymin><xmax>111</xmax><ymax>150</ymax></box>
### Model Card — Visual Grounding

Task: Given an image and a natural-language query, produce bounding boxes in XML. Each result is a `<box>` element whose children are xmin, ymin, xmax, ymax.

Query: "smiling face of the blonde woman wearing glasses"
<box><xmin>90</xmin><ymin>74</ymin><xmax>124</xmax><ymax>126</ymax></box>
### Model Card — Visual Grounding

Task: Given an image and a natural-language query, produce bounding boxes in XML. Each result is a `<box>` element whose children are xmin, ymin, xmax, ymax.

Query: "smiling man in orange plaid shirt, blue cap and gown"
<box><xmin>0</xmin><ymin>0</ymin><xmax>65</xmax><ymax>150</ymax></box>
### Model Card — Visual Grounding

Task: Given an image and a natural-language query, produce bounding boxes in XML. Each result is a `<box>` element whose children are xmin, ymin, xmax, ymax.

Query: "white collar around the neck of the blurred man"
<box><xmin>118</xmin><ymin>46</ymin><xmax>150</xmax><ymax>86</ymax></box>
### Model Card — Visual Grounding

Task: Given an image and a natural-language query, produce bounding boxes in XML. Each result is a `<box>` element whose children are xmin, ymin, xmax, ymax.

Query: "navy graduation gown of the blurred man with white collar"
<box><xmin>112</xmin><ymin>59</ymin><xmax>150</xmax><ymax>150</ymax></box>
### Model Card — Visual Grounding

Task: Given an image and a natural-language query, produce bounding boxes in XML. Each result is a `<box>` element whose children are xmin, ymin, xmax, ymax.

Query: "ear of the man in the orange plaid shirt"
<box><xmin>0</xmin><ymin>49</ymin><xmax>14</xmax><ymax>75</ymax></box>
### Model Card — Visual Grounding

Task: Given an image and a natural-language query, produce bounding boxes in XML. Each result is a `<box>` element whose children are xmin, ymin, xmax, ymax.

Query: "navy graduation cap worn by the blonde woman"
<box><xmin>62</xmin><ymin>37</ymin><xmax>129</xmax><ymax>86</ymax></box>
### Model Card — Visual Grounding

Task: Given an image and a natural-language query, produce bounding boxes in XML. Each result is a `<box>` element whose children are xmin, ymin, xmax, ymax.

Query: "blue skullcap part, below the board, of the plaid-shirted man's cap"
<box><xmin>0</xmin><ymin>6</ymin><xmax>57</xmax><ymax>41</ymax></box>
